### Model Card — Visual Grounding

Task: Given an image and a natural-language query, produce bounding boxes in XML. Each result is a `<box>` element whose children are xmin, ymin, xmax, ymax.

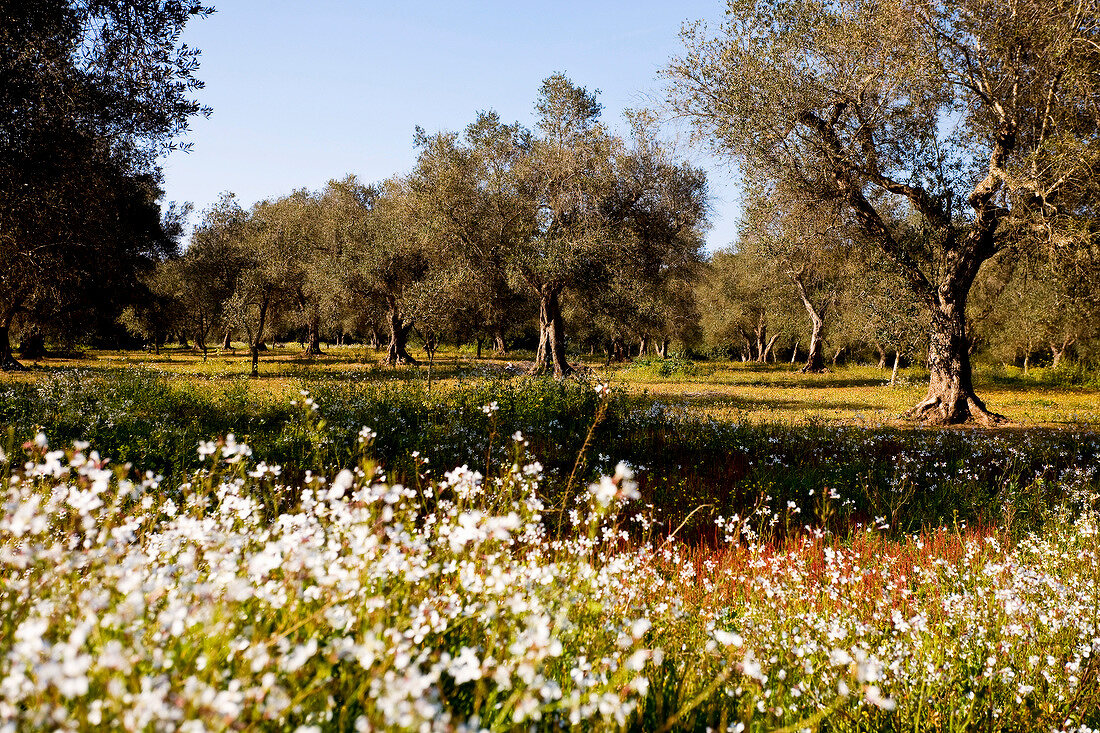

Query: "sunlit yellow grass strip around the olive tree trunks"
<box><xmin>8</xmin><ymin>347</ymin><xmax>1100</xmax><ymax>427</ymax></box>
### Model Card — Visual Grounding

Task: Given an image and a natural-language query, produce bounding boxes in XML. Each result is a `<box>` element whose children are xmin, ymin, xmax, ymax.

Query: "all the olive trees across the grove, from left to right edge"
<box><xmin>8</xmin><ymin>0</ymin><xmax>1100</xmax><ymax>423</ymax></box>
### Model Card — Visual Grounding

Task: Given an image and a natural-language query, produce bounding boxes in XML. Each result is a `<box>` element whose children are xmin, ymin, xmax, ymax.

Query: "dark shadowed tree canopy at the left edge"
<box><xmin>0</xmin><ymin>0</ymin><xmax>211</xmax><ymax>368</ymax></box>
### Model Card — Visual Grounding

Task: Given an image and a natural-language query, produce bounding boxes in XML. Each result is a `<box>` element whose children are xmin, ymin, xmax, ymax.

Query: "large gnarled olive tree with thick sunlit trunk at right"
<box><xmin>668</xmin><ymin>0</ymin><xmax>1100</xmax><ymax>423</ymax></box>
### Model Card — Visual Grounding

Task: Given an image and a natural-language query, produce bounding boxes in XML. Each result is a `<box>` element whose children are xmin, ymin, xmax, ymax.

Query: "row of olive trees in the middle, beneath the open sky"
<box><xmin>116</xmin><ymin>75</ymin><xmax>707</xmax><ymax>376</ymax></box>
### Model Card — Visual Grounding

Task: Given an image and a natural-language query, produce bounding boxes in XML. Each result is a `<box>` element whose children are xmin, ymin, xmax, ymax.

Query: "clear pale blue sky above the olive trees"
<box><xmin>164</xmin><ymin>0</ymin><xmax>738</xmax><ymax>249</ymax></box>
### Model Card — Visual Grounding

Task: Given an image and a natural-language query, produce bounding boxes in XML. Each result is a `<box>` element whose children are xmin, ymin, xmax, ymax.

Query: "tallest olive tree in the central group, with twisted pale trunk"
<box><xmin>410</xmin><ymin>74</ymin><xmax>706</xmax><ymax>376</ymax></box>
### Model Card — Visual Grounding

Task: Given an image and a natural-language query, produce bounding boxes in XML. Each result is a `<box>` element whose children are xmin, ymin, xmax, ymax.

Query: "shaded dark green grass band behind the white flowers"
<box><xmin>0</xmin><ymin>372</ymin><xmax>1100</xmax><ymax>537</ymax></box>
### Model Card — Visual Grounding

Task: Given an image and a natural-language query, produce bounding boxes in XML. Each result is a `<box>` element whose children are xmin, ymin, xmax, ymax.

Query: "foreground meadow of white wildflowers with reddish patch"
<box><xmin>0</xmin><ymin>372</ymin><xmax>1100</xmax><ymax>731</ymax></box>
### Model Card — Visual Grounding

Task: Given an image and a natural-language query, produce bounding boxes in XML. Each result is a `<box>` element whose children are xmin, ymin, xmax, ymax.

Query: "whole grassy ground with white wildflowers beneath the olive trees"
<box><xmin>0</xmin><ymin>349</ymin><xmax>1100</xmax><ymax>733</ymax></box>
